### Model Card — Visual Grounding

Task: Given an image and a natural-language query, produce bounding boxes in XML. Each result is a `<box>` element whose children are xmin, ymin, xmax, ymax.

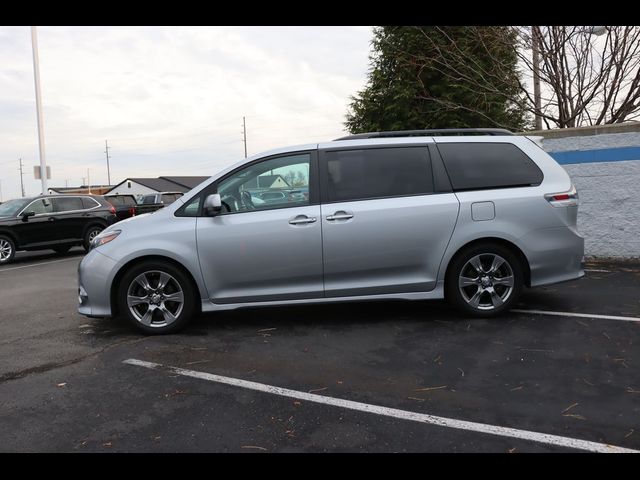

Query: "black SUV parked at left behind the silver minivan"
<box><xmin>0</xmin><ymin>195</ymin><xmax>118</xmax><ymax>265</ymax></box>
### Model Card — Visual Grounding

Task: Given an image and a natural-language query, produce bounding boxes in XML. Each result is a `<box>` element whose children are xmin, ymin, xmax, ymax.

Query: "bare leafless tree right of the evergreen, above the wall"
<box><xmin>407</xmin><ymin>26</ymin><xmax>640</xmax><ymax>128</ymax></box>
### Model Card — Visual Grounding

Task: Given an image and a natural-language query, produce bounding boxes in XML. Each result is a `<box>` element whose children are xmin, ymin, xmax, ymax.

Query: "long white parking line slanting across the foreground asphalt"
<box><xmin>123</xmin><ymin>358</ymin><xmax>640</xmax><ymax>453</ymax></box>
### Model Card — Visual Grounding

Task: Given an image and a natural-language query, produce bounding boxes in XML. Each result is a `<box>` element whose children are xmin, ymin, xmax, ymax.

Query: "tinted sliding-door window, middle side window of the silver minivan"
<box><xmin>325</xmin><ymin>147</ymin><xmax>433</xmax><ymax>202</ymax></box>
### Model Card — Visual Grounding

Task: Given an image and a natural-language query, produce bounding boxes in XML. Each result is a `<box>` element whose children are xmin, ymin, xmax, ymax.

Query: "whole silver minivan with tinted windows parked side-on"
<box><xmin>78</xmin><ymin>129</ymin><xmax>584</xmax><ymax>333</ymax></box>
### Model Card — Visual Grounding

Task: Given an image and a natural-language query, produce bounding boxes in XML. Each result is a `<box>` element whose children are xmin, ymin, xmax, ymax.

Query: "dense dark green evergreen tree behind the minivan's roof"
<box><xmin>345</xmin><ymin>26</ymin><xmax>529</xmax><ymax>133</ymax></box>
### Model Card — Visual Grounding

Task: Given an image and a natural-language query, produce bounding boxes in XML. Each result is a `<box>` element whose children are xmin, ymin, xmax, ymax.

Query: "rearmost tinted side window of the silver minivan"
<box><xmin>438</xmin><ymin>143</ymin><xmax>543</xmax><ymax>190</ymax></box>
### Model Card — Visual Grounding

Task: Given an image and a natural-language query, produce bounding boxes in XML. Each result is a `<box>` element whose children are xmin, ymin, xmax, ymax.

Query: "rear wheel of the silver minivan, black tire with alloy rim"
<box><xmin>445</xmin><ymin>242</ymin><xmax>524</xmax><ymax>318</ymax></box>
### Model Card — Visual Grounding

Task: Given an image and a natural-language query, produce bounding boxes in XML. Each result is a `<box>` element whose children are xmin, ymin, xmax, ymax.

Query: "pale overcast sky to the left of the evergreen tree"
<box><xmin>0</xmin><ymin>27</ymin><xmax>372</xmax><ymax>200</ymax></box>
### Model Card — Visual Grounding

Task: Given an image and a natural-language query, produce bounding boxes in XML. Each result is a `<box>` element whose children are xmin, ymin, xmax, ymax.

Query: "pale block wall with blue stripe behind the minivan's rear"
<box><xmin>526</xmin><ymin>123</ymin><xmax>640</xmax><ymax>258</ymax></box>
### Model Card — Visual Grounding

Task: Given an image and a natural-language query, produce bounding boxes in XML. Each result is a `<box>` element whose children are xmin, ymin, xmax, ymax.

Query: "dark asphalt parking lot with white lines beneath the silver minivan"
<box><xmin>0</xmin><ymin>249</ymin><xmax>640</xmax><ymax>452</ymax></box>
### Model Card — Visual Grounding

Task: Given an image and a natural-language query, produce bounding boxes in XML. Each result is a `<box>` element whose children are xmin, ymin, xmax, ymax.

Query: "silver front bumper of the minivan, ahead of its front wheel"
<box><xmin>78</xmin><ymin>249</ymin><xmax>117</xmax><ymax>317</ymax></box>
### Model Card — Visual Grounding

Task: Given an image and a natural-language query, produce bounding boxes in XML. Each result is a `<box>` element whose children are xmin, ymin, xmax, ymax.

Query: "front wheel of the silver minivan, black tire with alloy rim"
<box><xmin>117</xmin><ymin>260</ymin><xmax>198</xmax><ymax>335</ymax></box>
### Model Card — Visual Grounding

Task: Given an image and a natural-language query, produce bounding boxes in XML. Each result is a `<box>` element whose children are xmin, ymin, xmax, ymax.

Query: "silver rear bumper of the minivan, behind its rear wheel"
<box><xmin>519</xmin><ymin>227</ymin><xmax>584</xmax><ymax>287</ymax></box>
